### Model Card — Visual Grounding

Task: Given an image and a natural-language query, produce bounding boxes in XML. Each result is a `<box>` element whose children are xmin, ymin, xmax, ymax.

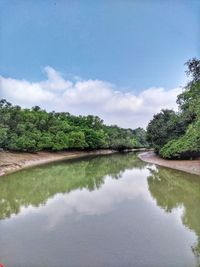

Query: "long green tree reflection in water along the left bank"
<box><xmin>0</xmin><ymin>153</ymin><xmax>146</xmax><ymax>219</ymax></box>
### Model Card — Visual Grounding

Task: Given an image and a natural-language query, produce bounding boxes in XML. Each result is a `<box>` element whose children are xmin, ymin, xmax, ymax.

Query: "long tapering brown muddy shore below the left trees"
<box><xmin>0</xmin><ymin>150</ymin><xmax>116</xmax><ymax>176</ymax></box>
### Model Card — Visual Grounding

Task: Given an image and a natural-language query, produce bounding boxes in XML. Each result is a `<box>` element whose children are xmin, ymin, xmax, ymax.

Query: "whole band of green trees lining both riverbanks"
<box><xmin>0</xmin><ymin>59</ymin><xmax>200</xmax><ymax>159</ymax></box>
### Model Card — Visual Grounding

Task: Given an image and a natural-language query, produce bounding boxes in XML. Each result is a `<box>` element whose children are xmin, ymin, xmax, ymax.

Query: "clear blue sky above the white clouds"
<box><xmin>0</xmin><ymin>0</ymin><xmax>200</xmax><ymax>129</ymax></box>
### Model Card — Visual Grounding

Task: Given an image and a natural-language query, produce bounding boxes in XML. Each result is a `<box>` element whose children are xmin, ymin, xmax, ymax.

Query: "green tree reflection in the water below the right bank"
<box><xmin>148</xmin><ymin>168</ymin><xmax>200</xmax><ymax>259</ymax></box>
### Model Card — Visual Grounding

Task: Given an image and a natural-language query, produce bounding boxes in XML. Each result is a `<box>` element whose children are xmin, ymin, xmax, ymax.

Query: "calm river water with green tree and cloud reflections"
<box><xmin>0</xmin><ymin>153</ymin><xmax>200</xmax><ymax>267</ymax></box>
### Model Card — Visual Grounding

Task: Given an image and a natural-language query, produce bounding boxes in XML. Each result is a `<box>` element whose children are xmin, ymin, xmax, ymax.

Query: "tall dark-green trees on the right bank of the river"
<box><xmin>147</xmin><ymin>59</ymin><xmax>200</xmax><ymax>159</ymax></box>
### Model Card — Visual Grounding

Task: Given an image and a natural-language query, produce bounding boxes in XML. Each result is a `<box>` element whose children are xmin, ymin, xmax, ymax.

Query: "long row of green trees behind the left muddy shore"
<box><xmin>0</xmin><ymin>99</ymin><xmax>148</xmax><ymax>152</ymax></box>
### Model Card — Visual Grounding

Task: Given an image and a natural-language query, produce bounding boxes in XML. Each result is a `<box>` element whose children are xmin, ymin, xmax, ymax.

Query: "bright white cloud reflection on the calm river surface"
<box><xmin>10</xmin><ymin>169</ymin><xmax>153</xmax><ymax>229</ymax></box>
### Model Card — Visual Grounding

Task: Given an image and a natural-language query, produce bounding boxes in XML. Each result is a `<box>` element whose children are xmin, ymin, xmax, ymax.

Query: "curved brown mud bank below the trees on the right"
<box><xmin>138</xmin><ymin>151</ymin><xmax>200</xmax><ymax>175</ymax></box>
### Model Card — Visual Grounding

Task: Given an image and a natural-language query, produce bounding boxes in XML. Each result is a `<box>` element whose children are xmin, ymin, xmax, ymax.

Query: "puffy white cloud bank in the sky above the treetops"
<box><xmin>0</xmin><ymin>66</ymin><xmax>181</xmax><ymax>128</ymax></box>
